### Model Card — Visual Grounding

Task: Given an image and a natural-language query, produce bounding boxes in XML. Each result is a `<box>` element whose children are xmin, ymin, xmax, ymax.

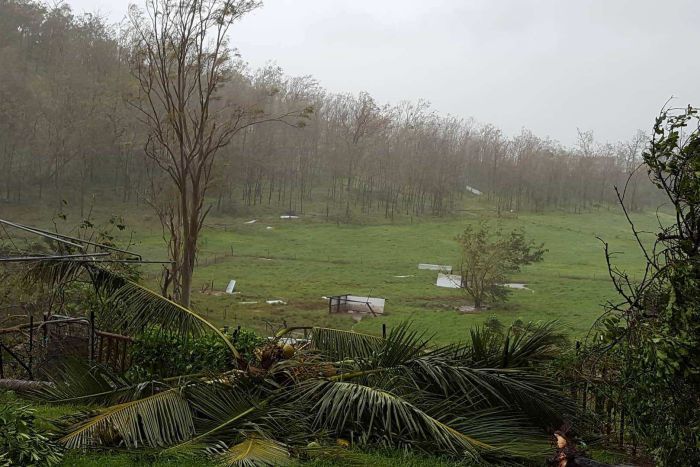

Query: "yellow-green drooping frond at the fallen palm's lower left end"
<box><xmin>59</xmin><ymin>389</ymin><xmax>194</xmax><ymax>449</ymax></box>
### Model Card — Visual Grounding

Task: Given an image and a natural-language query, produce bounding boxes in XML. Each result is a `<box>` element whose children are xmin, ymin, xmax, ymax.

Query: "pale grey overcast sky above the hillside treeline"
<box><xmin>63</xmin><ymin>0</ymin><xmax>700</xmax><ymax>144</ymax></box>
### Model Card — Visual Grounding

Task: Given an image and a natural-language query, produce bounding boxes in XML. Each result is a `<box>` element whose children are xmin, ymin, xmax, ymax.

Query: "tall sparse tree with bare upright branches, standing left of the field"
<box><xmin>129</xmin><ymin>0</ymin><xmax>311</xmax><ymax>306</ymax></box>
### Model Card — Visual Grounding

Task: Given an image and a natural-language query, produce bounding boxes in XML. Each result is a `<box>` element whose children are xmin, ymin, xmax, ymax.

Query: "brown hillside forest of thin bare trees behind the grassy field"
<box><xmin>0</xmin><ymin>0</ymin><xmax>653</xmax><ymax>217</ymax></box>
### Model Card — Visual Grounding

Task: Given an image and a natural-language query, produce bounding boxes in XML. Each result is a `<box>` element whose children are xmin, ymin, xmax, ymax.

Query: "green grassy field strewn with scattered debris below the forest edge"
<box><xmin>2</xmin><ymin>196</ymin><xmax>666</xmax><ymax>342</ymax></box>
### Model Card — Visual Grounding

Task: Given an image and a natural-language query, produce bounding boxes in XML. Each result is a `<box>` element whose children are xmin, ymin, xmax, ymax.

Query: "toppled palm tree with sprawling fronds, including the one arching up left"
<box><xmin>17</xmin><ymin>261</ymin><xmax>574</xmax><ymax>465</ymax></box>
